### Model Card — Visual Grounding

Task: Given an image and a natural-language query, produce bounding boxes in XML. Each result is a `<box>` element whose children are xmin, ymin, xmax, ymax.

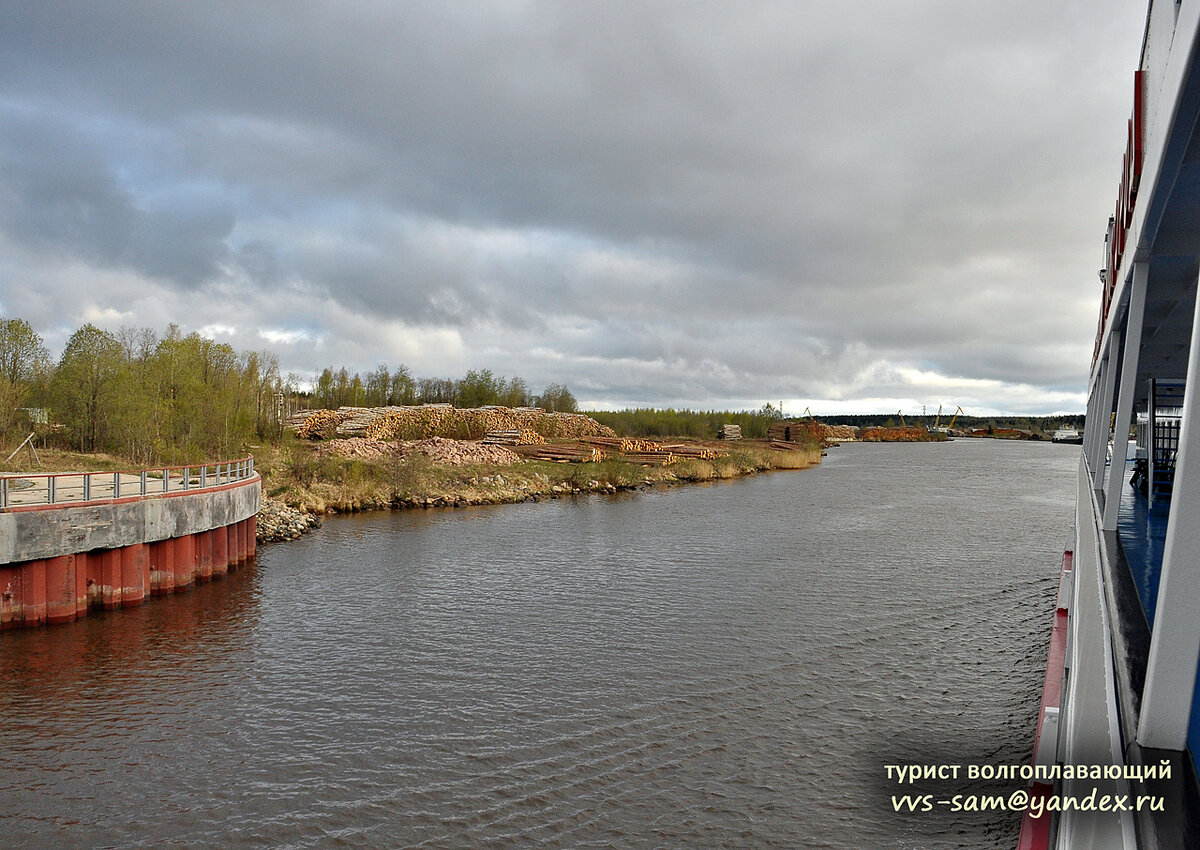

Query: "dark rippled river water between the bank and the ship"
<box><xmin>0</xmin><ymin>439</ymin><xmax>1079</xmax><ymax>848</ymax></box>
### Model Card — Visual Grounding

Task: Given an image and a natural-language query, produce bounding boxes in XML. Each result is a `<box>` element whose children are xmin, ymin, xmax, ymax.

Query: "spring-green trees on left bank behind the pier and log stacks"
<box><xmin>0</xmin><ymin>318</ymin><xmax>577</xmax><ymax>466</ymax></box>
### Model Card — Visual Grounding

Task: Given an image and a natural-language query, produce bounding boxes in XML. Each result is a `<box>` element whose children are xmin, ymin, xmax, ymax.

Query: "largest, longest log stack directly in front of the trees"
<box><xmin>288</xmin><ymin>405</ymin><xmax>616</xmax><ymax>439</ymax></box>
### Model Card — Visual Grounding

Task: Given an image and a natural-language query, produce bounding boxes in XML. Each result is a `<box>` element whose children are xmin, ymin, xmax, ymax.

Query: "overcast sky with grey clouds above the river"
<box><xmin>0</xmin><ymin>0</ymin><xmax>1145</xmax><ymax>414</ymax></box>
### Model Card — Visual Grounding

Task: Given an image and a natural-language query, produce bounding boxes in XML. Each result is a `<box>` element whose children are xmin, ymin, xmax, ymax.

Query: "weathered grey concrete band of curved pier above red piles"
<box><xmin>0</xmin><ymin>475</ymin><xmax>262</xmax><ymax>564</ymax></box>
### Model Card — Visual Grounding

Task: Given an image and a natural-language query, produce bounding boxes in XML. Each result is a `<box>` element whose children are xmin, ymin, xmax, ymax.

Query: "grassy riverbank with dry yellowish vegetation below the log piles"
<box><xmin>254</xmin><ymin>441</ymin><xmax>821</xmax><ymax>513</ymax></box>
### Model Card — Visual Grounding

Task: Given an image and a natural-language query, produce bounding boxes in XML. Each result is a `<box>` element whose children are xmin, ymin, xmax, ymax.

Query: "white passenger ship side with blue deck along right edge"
<box><xmin>1020</xmin><ymin>0</ymin><xmax>1200</xmax><ymax>850</ymax></box>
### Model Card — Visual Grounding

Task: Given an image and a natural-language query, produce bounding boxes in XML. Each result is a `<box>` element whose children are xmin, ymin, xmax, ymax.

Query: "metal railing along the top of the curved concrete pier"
<box><xmin>0</xmin><ymin>455</ymin><xmax>254</xmax><ymax>510</ymax></box>
